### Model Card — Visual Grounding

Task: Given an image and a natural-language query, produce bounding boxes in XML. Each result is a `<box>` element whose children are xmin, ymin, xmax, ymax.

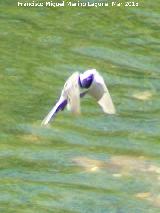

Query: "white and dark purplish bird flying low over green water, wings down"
<box><xmin>42</xmin><ymin>69</ymin><xmax>116</xmax><ymax>125</ymax></box>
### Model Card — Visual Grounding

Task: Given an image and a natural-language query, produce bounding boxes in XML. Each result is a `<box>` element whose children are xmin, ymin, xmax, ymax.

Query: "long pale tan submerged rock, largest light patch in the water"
<box><xmin>72</xmin><ymin>156</ymin><xmax>160</xmax><ymax>177</ymax></box>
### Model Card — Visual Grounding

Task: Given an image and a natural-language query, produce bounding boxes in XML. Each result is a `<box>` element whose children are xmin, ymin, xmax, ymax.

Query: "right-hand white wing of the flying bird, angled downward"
<box><xmin>88</xmin><ymin>72</ymin><xmax>116</xmax><ymax>114</ymax></box>
